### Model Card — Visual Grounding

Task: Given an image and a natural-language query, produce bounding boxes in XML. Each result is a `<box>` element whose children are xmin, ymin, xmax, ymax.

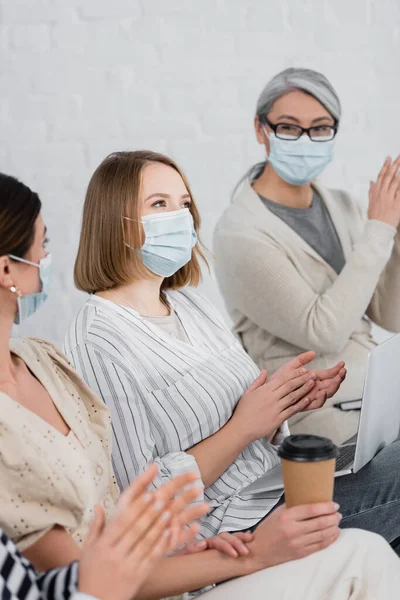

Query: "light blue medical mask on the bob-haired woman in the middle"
<box><xmin>124</xmin><ymin>208</ymin><xmax>197</xmax><ymax>277</ymax></box>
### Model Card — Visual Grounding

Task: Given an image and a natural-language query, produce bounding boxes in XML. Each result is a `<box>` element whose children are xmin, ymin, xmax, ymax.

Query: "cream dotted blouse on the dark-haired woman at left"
<box><xmin>0</xmin><ymin>339</ymin><xmax>119</xmax><ymax>550</ymax></box>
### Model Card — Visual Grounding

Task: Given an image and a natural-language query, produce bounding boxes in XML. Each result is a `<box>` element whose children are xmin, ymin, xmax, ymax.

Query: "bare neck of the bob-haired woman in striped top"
<box><xmin>97</xmin><ymin>277</ymin><xmax>169</xmax><ymax>317</ymax></box>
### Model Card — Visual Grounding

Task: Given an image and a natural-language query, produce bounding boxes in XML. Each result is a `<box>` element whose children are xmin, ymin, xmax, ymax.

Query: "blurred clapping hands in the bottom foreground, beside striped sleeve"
<box><xmin>79</xmin><ymin>465</ymin><xmax>208</xmax><ymax>600</ymax></box>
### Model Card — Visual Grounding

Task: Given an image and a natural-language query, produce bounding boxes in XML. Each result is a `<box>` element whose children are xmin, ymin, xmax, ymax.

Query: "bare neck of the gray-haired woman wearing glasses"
<box><xmin>253</xmin><ymin>163</ymin><xmax>313</xmax><ymax>208</ymax></box>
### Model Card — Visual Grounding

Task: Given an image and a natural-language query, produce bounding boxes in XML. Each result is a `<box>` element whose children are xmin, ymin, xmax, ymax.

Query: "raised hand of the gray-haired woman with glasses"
<box><xmin>368</xmin><ymin>156</ymin><xmax>400</xmax><ymax>229</ymax></box>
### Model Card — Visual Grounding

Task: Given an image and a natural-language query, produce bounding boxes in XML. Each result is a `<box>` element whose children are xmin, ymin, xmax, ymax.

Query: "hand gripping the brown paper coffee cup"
<box><xmin>248</xmin><ymin>502</ymin><xmax>342</xmax><ymax>568</ymax></box>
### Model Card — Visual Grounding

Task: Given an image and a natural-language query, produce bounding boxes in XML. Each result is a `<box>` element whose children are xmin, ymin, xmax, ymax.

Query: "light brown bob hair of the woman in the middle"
<box><xmin>74</xmin><ymin>150</ymin><xmax>208</xmax><ymax>294</ymax></box>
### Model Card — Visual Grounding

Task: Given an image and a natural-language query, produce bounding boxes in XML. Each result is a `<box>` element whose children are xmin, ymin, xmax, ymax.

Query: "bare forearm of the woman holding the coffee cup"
<box><xmin>135</xmin><ymin>550</ymin><xmax>255</xmax><ymax>600</ymax></box>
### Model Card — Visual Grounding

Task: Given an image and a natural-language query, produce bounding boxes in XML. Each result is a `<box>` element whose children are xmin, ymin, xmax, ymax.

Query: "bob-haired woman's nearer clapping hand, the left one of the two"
<box><xmin>232</xmin><ymin>353</ymin><xmax>316</xmax><ymax>444</ymax></box>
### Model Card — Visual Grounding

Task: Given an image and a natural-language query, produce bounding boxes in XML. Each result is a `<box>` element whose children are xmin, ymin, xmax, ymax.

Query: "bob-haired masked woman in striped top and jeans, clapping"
<box><xmin>65</xmin><ymin>152</ymin><xmax>400</xmax><ymax>542</ymax></box>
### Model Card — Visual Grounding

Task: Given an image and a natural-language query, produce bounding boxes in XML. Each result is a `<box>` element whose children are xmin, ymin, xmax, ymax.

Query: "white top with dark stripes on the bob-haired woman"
<box><xmin>65</xmin><ymin>288</ymin><xmax>279</xmax><ymax>537</ymax></box>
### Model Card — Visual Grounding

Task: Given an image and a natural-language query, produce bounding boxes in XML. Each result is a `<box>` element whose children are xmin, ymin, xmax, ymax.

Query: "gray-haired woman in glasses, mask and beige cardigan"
<box><xmin>214</xmin><ymin>68</ymin><xmax>400</xmax><ymax>442</ymax></box>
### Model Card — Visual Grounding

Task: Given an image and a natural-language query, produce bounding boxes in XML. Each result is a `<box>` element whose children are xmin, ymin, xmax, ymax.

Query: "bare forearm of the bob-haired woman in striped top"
<box><xmin>186</xmin><ymin>417</ymin><xmax>251</xmax><ymax>488</ymax></box>
